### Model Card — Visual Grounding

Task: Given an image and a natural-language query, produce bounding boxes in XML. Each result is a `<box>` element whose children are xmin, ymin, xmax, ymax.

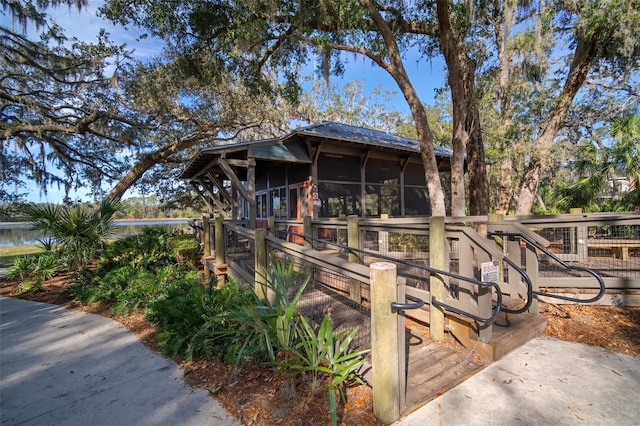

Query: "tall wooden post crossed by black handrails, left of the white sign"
<box><xmin>429</xmin><ymin>216</ymin><xmax>449</xmax><ymax>342</ymax></box>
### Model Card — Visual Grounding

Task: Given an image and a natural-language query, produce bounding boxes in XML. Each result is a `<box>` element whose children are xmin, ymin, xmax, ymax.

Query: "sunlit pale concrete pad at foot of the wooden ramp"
<box><xmin>395</xmin><ymin>337</ymin><xmax>640</xmax><ymax>426</ymax></box>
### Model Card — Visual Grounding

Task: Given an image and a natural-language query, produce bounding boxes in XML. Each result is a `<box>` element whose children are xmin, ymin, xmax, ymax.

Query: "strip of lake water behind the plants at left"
<box><xmin>0</xmin><ymin>219</ymin><xmax>191</xmax><ymax>247</ymax></box>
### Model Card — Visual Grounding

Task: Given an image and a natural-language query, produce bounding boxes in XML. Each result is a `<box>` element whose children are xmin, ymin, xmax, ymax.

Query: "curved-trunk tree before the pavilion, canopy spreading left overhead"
<box><xmin>104</xmin><ymin>0</ymin><xmax>464</xmax><ymax>215</ymax></box>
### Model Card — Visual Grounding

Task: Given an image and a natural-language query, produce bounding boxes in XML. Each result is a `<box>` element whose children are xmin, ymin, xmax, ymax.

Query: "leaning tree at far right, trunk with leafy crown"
<box><xmin>516</xmin><ymin>0</ymin><xmax>640</xmax><ymax>215</ymax></box>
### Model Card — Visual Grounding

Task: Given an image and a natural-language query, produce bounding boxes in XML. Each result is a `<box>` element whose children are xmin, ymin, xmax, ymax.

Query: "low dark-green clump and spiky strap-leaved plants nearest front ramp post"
<box><xmin>147</xmin><ymin>255</ymin><xmax>368</xmax><ymax>425</ymax></box>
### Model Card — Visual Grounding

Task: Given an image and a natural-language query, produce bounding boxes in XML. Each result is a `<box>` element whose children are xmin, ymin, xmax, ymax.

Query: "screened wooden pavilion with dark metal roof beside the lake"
<box><xmin>180</xmin><ymin>122</ymin><xmax>451</xmax><ymax>228</ymax></box>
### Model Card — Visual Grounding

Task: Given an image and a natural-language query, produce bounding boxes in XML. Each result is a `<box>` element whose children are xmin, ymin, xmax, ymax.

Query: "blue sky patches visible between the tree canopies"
<box><xmin>0</xmin><ymin>0</ymin><xmax>445</xmax><ymax>203</ymax></box>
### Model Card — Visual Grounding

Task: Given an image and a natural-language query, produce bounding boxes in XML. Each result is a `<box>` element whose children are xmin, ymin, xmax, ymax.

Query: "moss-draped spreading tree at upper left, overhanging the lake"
<box><xmin>0</xmin><ymin>1</ymin><xmax>288</xmax><ymax>203</ymax></box>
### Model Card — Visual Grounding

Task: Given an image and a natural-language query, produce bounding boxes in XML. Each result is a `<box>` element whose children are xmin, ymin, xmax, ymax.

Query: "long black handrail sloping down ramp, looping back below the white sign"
<box><xmin>267</xmin><ymin>227</ymin><xmax>502</xmax><ymax>324</ymax></box>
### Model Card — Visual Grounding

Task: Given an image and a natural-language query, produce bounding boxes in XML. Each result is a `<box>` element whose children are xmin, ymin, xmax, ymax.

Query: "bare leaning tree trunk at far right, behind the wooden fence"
<box><xmin>516</xmin><ymin>38</ymin><xmax>596</xmax><ymax>216</ymax></box>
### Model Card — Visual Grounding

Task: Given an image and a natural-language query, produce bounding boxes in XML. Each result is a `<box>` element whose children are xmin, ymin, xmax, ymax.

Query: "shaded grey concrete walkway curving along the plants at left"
<box><xmin>0</xmin><ymin>297</ymin><xmax>240</xmax><ymax>426</ymax></box>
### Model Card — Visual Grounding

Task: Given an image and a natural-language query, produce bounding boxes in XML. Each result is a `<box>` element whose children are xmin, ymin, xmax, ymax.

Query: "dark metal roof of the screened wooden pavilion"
<box><xmin>180</xmin><ymin>121</ymin><xmax>451</xmax><ymax>179</ymax></box>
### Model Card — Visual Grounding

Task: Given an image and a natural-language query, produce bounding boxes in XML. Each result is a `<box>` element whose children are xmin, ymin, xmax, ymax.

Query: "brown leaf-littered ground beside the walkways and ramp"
<box><xmin>0</xmin><ymin>275</ymin><xmax>640</xmax><ymax>426</ymax></box>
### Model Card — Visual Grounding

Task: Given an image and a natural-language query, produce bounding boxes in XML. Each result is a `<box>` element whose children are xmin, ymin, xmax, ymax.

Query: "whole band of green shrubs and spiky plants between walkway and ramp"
<box><xmin>62</xmin><ymin>223</ymin><xmax>367</xmax><ymax>424</ymax></box>
